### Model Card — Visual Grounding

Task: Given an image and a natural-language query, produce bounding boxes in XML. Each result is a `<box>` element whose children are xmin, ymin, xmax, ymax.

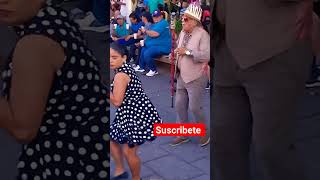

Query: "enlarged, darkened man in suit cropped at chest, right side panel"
<box><xmin>212</xmin><ymin>0</ymin><xmax>312</xmax><ymax>180</ymax></box>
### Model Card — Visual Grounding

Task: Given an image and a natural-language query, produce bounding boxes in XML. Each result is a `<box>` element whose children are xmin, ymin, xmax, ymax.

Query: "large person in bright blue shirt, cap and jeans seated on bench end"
<box><xmin>135</xmin><ymin>10</ymin><xmax>172</xmax><ymax>76</ymax></box>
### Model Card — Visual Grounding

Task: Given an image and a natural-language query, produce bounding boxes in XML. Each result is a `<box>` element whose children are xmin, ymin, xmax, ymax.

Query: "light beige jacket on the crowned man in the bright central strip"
<box><xmin>178</xmin><ymin>27</ymin><xmax>210</xmax><ymax>83</ymax></box>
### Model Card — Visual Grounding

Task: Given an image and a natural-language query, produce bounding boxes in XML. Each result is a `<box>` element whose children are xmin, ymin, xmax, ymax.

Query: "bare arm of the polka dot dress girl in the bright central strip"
<box><xmin>110</xmin><ymin>72</ymin><xmax>130</xmax><ymax>107</ymax></box>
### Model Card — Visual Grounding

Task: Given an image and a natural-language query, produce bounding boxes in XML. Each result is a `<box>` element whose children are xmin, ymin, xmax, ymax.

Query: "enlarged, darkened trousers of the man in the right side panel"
<box><xmin>211</xmin><ymin>42</ymin><xmax>312</xmax><ymax>180</ymax></box>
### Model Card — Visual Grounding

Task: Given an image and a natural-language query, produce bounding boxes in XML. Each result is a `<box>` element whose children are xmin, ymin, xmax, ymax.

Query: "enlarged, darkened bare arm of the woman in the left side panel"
<box><xmin>0</xmin><ymin>35</ymin><xmax>64</xmax><ymax>143</ymax></box>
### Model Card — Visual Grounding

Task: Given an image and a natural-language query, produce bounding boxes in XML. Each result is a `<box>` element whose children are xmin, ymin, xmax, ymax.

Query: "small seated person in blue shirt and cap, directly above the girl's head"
<box><xmin>112</xmin><ymin>15</ymin><xmax>129</xmax><ymax>45</ymax></box>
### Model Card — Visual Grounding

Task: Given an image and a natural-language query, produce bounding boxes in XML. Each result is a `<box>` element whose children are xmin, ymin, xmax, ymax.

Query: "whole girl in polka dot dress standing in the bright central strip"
<box><xmin>110</xmin><ymin>43</ymin><xmax>161</xmax><ymax>180</ymax></box>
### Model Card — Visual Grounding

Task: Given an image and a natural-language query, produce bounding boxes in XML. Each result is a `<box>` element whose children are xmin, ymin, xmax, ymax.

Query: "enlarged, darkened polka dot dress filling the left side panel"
<box><xmin>2</xmin><ymin>3</ymin><xmax>110</xmax><ymax>180</ymax></box>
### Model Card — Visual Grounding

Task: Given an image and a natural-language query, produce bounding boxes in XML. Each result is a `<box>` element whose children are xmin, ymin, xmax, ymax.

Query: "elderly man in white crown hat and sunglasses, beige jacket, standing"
<box><xmin>171</xmin><ymin>4</ymin><xmax>210</xmax><ymax>146</ymax></box>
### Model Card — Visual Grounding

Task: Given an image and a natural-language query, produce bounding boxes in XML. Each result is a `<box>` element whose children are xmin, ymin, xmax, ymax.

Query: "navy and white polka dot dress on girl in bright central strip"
<box><xmin>110</xmin><ymin>63</ymin><xmax>162</xmax><ymax>147</ymax></box>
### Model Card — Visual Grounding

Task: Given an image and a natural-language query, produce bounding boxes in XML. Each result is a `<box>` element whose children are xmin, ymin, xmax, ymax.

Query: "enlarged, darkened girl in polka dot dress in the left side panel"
<box><xmin>0</xmin><ymin>0</ymin><xmax>109</xmax><ymax>180</ymax></box>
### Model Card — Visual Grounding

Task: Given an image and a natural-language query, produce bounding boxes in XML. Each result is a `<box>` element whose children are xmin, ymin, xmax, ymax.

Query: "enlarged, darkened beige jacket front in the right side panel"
<box><xmin>217</xmin><ymin>0</ymin><xmax>303</xmax><ymax>69</ymax></box>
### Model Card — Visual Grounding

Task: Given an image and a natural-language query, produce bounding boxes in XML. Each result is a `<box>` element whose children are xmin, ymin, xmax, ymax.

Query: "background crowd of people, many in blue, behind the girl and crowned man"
<box><xmin>110</xmin><ymin>0</ymin><xmax>210</xmax><ymax>76</ymax></box>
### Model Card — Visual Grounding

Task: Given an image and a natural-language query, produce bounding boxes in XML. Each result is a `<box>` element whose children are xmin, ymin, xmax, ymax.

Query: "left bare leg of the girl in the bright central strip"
<box><xmin>110</xmin><ymin>141</ymin><xmax>125</xmax><ymax>176</ymax></box>
